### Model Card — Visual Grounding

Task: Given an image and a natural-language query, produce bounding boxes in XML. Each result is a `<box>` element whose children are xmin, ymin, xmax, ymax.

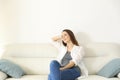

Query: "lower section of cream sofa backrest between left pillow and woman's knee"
<box><xmin>3</xmin><ymin>57</ymin><xmax>52</xmax><ymax>75</ymax></box>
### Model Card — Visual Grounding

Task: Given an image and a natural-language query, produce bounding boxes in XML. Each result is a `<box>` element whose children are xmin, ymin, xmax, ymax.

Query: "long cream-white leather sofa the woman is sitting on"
<box><xmin>2</xmin><ymin>43</ymin><xmax>120</xmax><ymax>80</ymax></box>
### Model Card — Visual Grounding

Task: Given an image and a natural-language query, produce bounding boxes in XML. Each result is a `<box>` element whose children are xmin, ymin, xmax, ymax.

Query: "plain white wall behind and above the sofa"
<box><xmin>0</xmin><ymin>0</ymin><xmax>120</xmax><ymax>43</ymax></box>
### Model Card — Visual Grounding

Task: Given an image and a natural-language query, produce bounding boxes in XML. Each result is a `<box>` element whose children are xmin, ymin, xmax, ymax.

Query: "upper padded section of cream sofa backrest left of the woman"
<box><xmin>4</xmin><ymin>43</ymin><xmax>58</xmax><ymax>58</ymax></box>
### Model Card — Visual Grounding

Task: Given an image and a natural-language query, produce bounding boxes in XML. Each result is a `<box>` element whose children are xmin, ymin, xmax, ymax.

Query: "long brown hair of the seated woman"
<box><xmin>62</xmin><ymin>29</ymin><xmax>79</xmax><ymax>46</ymax></box>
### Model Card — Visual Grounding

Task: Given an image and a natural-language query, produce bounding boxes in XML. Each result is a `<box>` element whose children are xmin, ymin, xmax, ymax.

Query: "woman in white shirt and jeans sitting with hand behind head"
<box><xmin>48</xmin><ymin>29</ymin><xmax>88</xmax><ymax>80</ymax></box>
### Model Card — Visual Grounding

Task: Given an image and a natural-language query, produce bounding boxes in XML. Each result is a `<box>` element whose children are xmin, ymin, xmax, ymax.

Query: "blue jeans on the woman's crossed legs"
<box><xmin>48</xmin><ymin>60</ymin><xmax>80</xmax><ymax>80</ymax></box>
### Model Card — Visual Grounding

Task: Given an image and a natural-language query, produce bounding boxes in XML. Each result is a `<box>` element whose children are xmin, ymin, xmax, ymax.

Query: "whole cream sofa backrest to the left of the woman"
<box><xmin>2</xmin><ymin>43</ymin><xmax>58</xmax><ymax>74</ymax></box>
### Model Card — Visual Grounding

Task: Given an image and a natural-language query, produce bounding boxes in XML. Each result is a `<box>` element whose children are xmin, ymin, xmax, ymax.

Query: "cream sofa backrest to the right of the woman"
<box><xmin>84</xmin><ymin>43</ymin><xmax>120</xmax><ymax>74</ymax></box>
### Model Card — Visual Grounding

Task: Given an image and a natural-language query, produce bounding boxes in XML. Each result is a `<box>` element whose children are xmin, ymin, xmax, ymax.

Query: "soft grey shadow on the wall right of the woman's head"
<box><xmin>76</xmin><ymin>32</ymin><xmax>92</xmax><ymax>45</ymax></box>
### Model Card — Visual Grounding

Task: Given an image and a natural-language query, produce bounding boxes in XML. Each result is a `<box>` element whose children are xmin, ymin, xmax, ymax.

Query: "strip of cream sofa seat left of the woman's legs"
<box><xmin>6</xmin><ymin>75</ymin><xmax>47</xmax><ymax>80</ymax></box>
